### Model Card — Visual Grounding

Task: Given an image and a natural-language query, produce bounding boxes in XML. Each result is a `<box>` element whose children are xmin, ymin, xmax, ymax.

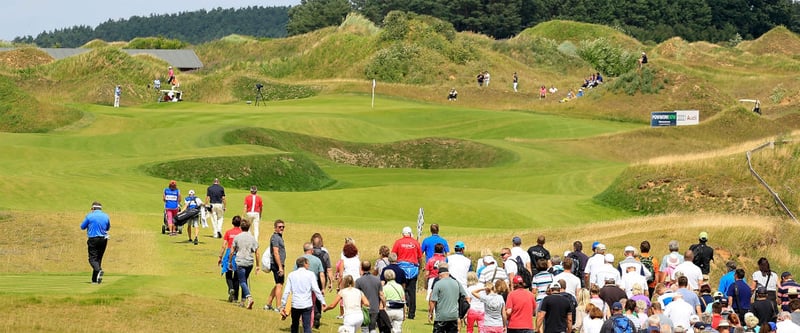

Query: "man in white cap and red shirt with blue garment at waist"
<box><xmin>392</xmin><ymin>227</ymin><xmax>425</xmax><ymax>319</ymax></box>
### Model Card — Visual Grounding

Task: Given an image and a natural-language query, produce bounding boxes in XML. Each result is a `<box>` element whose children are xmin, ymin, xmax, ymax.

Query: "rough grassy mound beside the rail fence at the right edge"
<box><xmin>596</xmin><ymin>140</ymin><xmax>800</xmax><ymax>216</ymax></box>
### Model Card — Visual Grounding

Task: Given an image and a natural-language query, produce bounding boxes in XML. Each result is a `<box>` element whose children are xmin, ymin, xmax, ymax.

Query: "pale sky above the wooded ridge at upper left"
<box><xmin>0</xmin><ymin>0</ymin><xmax>300</xmax><ymax>41</ymax></box>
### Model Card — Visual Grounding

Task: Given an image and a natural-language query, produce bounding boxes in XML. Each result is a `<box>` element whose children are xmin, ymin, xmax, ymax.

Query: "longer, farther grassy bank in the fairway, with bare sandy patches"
<box><xmin>225</xmin><ymin>128</ymin><xmax>514</xmax><ymax>169</ymax></box>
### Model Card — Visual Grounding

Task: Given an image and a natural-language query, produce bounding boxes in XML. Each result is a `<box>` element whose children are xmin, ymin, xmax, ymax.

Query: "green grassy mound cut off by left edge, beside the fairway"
<box><xmin>0</xmin><ymin>76</ymin><xmax>81</xmax><ymax>133</ymax></box>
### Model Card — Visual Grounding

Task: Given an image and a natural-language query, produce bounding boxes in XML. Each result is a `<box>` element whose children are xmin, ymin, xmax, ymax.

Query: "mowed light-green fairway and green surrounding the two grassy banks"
<box><xmin>0</xmin><ymin>95</ymin><xmax>643</xmax><ymax>332</ymax></box>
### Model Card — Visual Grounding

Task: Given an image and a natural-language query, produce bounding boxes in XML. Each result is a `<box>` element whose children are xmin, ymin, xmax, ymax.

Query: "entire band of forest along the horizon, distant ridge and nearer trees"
<box><xmin>13</xmin><ymin>0</ymin><xmax>800</xmax><ymax>47</ymax></box>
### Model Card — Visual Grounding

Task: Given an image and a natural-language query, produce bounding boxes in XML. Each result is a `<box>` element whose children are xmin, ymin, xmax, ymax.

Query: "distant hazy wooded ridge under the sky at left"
<box><xmin>13</xmin><ymin>6</ymin><xmax>289</xmax><ymax>47</ymax></box>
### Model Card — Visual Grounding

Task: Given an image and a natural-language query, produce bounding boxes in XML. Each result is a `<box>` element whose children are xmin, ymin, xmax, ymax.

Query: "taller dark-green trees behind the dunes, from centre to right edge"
<box><xmin>287</xmin><ymin>0</ymin><xmax>800</xmax><ymax>43</ymax></box>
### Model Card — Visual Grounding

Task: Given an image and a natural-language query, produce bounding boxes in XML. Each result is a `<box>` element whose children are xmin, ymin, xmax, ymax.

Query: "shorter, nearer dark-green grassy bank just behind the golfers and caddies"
<box><xmin>146</xmin><ymin>154</ymin><xmax>335</xmax><ymax>192</ymax></box>
